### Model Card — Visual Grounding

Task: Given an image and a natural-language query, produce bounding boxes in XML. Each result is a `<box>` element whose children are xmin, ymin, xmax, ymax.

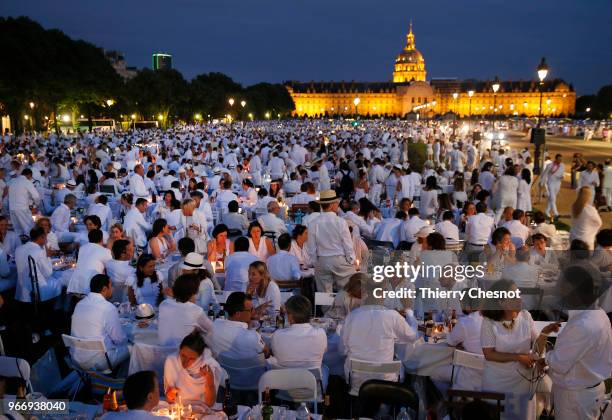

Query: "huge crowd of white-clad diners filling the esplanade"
<box><xmin>0</xmin><ymin>120</ymin><xmax>612</xmax><ymax>419</ymax></box>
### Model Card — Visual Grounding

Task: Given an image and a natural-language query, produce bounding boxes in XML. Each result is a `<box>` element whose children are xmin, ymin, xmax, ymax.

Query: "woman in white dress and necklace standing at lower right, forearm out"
<box><xmin>480</xmin><ymin>280</ymin><xmax>558</xmax><ymax>419</ymax></box>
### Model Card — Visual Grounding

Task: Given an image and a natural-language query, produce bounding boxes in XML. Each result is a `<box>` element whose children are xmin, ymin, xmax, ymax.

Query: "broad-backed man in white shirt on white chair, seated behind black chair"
<box><xmin>339</xmin><ymin>276</ymin><xmax>417</xmax><ymax>381</ymax></box>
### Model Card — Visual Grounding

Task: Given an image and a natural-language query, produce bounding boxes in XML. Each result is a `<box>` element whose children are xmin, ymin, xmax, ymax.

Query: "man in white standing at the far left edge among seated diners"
<box><xmin>8</xmin><ymin>168</ymin><xmax>41</xmax><ymax>235</ymax></box>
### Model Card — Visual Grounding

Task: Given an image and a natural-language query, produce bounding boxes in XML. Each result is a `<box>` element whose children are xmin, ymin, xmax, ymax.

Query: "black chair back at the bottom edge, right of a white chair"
<box><xmin>358</xmin><ymin>379</ymin><xmax>419</xmax><ymax>418</ymax></box>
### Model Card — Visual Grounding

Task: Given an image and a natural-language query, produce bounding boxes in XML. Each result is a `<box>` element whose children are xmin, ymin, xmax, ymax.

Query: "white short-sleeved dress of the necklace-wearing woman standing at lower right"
<box><xmin>480</xmin><ymin>310</ymin><xmax>538</xmax><ymax>420</ymax></box>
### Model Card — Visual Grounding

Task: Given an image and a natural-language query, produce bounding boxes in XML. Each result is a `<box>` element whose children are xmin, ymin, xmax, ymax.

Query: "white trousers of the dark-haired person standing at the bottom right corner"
<box><xmin>553</xmin><ymin>382</ymin><xmax>608</xmax><ymax>420</ymax></box>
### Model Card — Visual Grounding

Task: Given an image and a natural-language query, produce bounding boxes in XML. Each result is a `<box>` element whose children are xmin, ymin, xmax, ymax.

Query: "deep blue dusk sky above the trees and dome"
<box><xmin>0</xmin><ymin>0</ymin><xmax>612</xmax><ymax>95</ymax></box>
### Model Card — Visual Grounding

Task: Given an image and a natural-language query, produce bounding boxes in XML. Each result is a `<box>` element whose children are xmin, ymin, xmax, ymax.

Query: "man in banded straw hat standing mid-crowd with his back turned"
<box><xmin>306</xmin><ymin>190</ymin><xmax>355</xmax><ymax>292</ymax></box>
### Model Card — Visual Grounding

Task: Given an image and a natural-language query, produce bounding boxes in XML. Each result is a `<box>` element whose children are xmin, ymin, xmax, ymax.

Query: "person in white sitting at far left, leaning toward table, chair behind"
<box><xmin>15</xmin><ymin>227</ymin><xmax>62</xmax><ymax>303</ymax></box>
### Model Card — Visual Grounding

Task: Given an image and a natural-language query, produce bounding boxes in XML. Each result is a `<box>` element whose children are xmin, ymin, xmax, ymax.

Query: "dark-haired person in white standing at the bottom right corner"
<box><xmin>541</xmin><ymin>266</ymin><xmax>612</xmax><ymax>420</ymax></box>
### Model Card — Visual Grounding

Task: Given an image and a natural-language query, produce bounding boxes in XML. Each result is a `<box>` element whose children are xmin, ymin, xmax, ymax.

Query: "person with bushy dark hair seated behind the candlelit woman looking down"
<box><xmin>157</xmin><ymin>274</ymin><xmax>212</xmax><ymax>346</ymax></box>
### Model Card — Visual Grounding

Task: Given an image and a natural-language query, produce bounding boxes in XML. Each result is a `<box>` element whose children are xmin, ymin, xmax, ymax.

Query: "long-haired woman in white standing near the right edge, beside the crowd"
<box><xmin>570</xmin><ymin>187</ymin><xmax>603</xmax><ymax>250</ymax></box>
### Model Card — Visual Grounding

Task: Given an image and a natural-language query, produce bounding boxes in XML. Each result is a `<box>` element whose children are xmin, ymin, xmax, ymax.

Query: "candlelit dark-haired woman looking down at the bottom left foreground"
<box><xmin>164</xmin><ymin>331</ymin><xmax>225</xmax><ymax>407</ymax></box>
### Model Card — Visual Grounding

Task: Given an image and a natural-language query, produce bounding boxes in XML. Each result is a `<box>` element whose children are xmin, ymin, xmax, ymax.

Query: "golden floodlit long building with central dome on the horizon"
<box><xmin>285</xmin><ymin>23</ymin><xmax>576</xmax><ymax>117</ymax></box>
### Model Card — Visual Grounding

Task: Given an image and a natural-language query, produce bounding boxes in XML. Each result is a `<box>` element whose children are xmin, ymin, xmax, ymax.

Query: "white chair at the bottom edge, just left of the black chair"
<box><xmin>258</xmin><ymin>368</ymin><xmax>318</xmax><ymax>414</ymax></box>
